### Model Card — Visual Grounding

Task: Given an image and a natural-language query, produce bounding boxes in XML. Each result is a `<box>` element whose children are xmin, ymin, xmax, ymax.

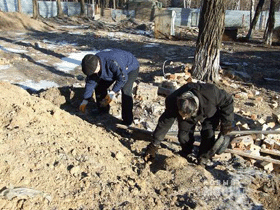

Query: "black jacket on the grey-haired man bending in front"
<box><xmin>154</xmin><ymin>83</ymin><xmax>234</xmax><ymax>142</ymax></box>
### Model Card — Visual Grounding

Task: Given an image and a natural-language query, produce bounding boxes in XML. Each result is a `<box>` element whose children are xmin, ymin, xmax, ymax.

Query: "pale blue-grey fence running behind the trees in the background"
<box><xmin>0</xmin><ymin>0</ymin><xmax>280</xmax><ymax>29</ymax></box>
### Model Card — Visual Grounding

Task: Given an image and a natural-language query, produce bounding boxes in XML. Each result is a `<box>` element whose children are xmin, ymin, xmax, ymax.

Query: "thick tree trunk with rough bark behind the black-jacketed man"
<box><xmin>192</xmin><ymin>0</ymin><xmax>227</xmax><ymax>82</ymax></box>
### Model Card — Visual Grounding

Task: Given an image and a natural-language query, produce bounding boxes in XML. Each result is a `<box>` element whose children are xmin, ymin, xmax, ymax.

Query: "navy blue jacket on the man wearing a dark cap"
<box><xmin>84</xmin><ymin>49</ymin><xmax>139</xmax><ymax>99</ymax></box>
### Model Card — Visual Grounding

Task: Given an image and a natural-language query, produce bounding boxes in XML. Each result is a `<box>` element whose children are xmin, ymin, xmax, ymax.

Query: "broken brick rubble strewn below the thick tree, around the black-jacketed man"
<box><xmin>130</xmin><ymin>61</ymin><xmax>280</xmax><ymax>173</ymax></box>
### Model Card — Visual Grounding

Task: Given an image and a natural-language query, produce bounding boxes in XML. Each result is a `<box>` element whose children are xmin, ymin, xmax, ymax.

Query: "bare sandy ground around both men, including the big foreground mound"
<box><xmin>0</xmin><ymin>12</ymin><xmax>280</xmax><ymax>210</ymax></box>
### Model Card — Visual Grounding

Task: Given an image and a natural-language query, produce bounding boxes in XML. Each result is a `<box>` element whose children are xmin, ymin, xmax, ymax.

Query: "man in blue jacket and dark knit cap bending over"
<box><xmin>79</xmin><ymin>49</ymin><xmax>139</xmax><ymax>125</ymax></box>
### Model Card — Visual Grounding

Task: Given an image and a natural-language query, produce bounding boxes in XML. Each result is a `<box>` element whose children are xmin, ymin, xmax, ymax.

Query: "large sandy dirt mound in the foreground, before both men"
<box><xmin>0</xmin><ymin>82</ymin><xmax>278</xmax><ymax>209</ymax></box>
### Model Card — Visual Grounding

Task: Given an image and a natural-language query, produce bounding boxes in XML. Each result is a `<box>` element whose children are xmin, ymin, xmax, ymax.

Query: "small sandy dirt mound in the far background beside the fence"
<box><xmin>0</xmin><ymin>11</ymin><xmax>50</xmax><ymax>31</ymax></box>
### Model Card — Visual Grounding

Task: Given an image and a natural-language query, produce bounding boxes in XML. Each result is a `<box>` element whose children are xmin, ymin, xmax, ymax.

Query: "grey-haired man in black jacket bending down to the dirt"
<box><xmin>144</xmin><ymin>83</ymin><xmax>234</xmax><ymax>164</ymax></box>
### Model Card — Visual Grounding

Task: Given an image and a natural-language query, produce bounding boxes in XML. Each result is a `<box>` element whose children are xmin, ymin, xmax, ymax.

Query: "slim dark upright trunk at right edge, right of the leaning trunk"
<box><xmin>264</xmin><ymin>0</ymin><xmax>276</xmax><ymax>46</ymax></box>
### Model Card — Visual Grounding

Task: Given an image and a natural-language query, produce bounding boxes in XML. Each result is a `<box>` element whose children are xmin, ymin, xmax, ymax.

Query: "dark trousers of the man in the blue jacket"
<box><xmin>95</xmin><ymin>68</ymin><xmax>139</xmax><ymax>125</ymax></box>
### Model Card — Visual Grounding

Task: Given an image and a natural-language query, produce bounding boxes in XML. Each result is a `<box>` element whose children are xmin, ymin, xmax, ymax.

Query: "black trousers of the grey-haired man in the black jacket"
<box><xmin>178</xmin><ymin>111</ymin><xmax>220</xmax><ymax>156</ymax></box>
